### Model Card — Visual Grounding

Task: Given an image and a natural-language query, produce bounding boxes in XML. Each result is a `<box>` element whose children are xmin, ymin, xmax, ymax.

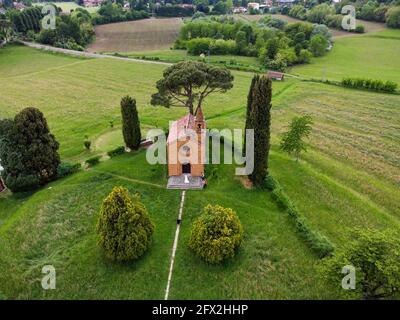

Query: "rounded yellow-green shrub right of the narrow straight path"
<box><xmin>189</xmin><ymin>205</ymin><xmax>243</xmax><ymax>263</ymax></box>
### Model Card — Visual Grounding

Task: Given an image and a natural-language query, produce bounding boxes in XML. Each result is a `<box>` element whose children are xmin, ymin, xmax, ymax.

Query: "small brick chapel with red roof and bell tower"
<box><xmin>167</xmin><ymin>108</ymin><xmax>206</xmax><ymax>189</ymax></box>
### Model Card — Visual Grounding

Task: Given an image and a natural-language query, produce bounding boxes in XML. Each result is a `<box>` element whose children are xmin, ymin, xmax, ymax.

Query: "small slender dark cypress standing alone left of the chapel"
<box><xmin>121</xmin><ymin>96</ymin><xmax>142</xmax><ymax>150</ymax></box>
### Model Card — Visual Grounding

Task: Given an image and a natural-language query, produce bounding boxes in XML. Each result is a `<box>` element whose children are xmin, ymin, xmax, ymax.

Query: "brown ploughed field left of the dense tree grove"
<box><xmin>88</xmin><ymin>18</ymin><xmax>182</xmax><ymax>52</ymax></box>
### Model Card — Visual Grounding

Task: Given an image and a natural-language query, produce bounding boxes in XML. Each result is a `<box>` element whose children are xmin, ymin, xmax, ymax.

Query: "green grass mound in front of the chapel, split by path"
<box><xmin>0</xmin><ymin>152</ymin><xmax>329</xmax><ymax>299</ymax></box>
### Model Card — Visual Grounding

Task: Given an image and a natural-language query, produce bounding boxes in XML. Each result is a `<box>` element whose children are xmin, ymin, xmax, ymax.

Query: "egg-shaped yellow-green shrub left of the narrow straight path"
<box><xmin>97</xmin><ymin>187</ymin><xmax>154</xmax><ymax>261</ymax></box>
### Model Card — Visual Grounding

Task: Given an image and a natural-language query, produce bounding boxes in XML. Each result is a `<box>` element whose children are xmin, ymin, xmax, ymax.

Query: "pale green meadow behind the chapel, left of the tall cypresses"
<box><xmin>0</xmin><ymin>46</ymin><xmax>287</xmax><ymax>160</ymax></box>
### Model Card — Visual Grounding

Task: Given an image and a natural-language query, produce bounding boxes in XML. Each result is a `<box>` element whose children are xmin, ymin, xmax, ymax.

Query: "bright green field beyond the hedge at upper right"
<box><xmin>290</xmin><ymin>29</ymin><xmax>400</xmax><ymax>85</ymax></box>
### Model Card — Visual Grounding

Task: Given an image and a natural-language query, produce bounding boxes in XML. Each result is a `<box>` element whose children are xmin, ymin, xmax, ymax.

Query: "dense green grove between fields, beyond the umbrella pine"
<box><xmin>175</xmin><ymin>16</ymin><xmax>332</xmax><ymax>71</ymax></box>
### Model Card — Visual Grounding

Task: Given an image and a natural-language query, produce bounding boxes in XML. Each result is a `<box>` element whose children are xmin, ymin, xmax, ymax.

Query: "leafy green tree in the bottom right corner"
<box><xmin>321</xmin><ymin>230</ymin><xmax>400</xmax><ymax>299</ymax></box>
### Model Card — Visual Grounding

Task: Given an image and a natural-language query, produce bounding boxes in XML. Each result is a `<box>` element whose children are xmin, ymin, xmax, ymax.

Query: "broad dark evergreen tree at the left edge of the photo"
<box><xmin>0</xmin><ymin>108</ymin><xmax>60</xmax><ymax>192</ymax></box>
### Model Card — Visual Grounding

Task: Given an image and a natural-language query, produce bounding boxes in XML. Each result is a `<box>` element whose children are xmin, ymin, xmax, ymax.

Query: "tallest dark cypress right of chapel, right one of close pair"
<box><xmin>249</xmin><ymin>76</ymin><xmax>272</xmax><ymax>186</ymax></box>
